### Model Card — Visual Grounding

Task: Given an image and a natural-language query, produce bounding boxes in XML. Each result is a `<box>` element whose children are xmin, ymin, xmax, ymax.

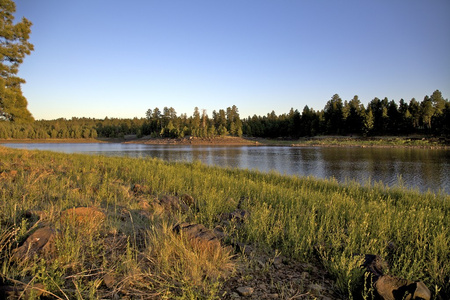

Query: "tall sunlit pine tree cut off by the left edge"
<box><xmin>0</xmin><ymin>0</ymin><xmax>33</xmax><ymax>122</ymax></box>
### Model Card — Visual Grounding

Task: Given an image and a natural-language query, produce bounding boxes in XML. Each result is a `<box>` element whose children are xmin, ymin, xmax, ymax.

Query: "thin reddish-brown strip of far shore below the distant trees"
<box><xmin>0</xmin><ymin>135</ymin><xmax>450</xmax><ymax>149</ymax></box>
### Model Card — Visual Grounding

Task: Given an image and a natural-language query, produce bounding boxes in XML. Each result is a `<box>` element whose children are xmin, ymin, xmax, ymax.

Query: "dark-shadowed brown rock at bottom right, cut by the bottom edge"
<box><xmin>374</xmin><ymin>275</ymin><xmax>431</xmax><ymax>300</ymax></box>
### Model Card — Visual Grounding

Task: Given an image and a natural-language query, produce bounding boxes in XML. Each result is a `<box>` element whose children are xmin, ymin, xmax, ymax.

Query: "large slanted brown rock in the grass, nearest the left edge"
<box><xmin>12</xmin><ymin>227</ymin><xmax>56</xmax><ymax>261</ymax></box>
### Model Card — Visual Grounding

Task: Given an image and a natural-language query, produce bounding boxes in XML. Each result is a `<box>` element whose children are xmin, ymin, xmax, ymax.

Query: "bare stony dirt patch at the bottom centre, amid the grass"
<box><xmin>222</xmin><ymin>246</ymin><xmax>340</xmax><ymax>299</ymax></box>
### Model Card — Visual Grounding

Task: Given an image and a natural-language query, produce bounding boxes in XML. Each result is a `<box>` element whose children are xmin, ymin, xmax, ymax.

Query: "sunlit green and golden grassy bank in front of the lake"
<box><xmin>0</xmin><ymin>146</ymin><xmax>450</xmax><ymax>299</ymax></box>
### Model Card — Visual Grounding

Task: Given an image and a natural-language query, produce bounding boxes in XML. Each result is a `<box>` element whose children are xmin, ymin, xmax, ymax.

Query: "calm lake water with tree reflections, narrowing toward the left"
<box><xmin>3</xmin><ymin>144</ymin><xmax>450</xmax><ymax>194</ymax></box>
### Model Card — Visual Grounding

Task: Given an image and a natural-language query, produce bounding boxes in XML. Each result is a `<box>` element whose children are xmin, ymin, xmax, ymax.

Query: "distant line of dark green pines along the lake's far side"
<box><xmin>0</xmin><ymin>90</ymin><xmax>450</xmax><ymax>139</ymax></box>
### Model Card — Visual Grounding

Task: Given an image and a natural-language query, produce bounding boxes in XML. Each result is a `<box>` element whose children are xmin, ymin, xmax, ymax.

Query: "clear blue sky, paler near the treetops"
<box><xmin>15</xmin><ymin>0</ymin><xmax>450</xmax><ymax>119</ymax></box>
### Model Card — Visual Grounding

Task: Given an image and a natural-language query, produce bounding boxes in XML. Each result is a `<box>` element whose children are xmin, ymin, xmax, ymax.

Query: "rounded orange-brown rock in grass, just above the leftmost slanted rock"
<box><xmin>60</xmin><ymin>207</ymin><xmax>106</xmax><ymax>231</ymax></box>
